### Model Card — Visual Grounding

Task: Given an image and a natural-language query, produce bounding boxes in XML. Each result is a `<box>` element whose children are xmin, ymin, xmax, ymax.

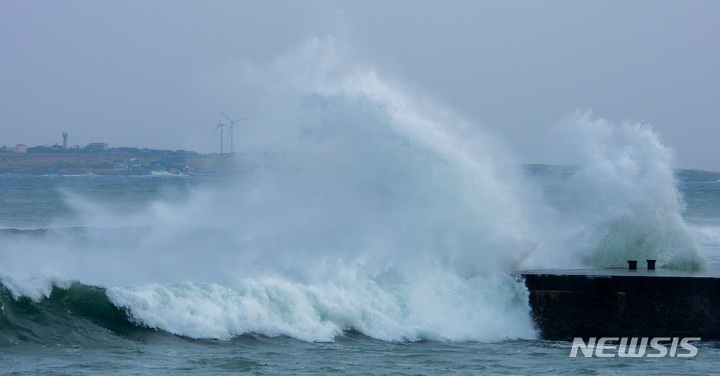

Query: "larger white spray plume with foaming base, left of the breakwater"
<box><xmin>3</xmin><ymin>40</ymin><xmax>535</xmax><ymax>341</ymax></box>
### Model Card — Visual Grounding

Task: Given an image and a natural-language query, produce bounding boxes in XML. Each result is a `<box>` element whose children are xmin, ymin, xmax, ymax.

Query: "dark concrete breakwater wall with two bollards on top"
<box><xmin>520</xmin><ymin>273</ymin><xmax>720</xmax><ymax>340</ymax></box>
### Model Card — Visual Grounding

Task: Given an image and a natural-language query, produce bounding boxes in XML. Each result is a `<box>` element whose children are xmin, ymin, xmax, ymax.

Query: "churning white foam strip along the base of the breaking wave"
<box><xmin>108</xmin><ymin>268</ymin><xmax>533</xmax><ymax>341</ymax></box>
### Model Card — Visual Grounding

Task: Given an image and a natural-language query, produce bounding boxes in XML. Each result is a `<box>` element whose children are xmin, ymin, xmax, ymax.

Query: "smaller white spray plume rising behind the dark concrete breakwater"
<box><xmin>528</xmin><ymin>111</ymin><xmax>704</xmax><ymax>269</ymax></box>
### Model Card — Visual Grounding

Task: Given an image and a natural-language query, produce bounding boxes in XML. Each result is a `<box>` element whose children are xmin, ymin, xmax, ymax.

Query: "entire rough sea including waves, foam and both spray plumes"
<box><xmin>0</xmin><ymin>50</ymin><xmax>720</xmax><ymax>376</ymax></box>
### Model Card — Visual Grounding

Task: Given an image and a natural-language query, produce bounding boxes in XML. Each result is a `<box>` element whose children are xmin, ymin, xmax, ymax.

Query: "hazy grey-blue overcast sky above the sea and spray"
<box><xmin>0</xmin><ymin>0</ymin><xmax>720</xmax><ymax>170</ymax></box>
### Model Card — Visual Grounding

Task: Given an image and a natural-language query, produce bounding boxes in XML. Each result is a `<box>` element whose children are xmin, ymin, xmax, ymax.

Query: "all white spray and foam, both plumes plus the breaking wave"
<box><xmin>0</xmin><ymin>38</ymin><xmax>702</xmax><ymax>341</ymax></box>
